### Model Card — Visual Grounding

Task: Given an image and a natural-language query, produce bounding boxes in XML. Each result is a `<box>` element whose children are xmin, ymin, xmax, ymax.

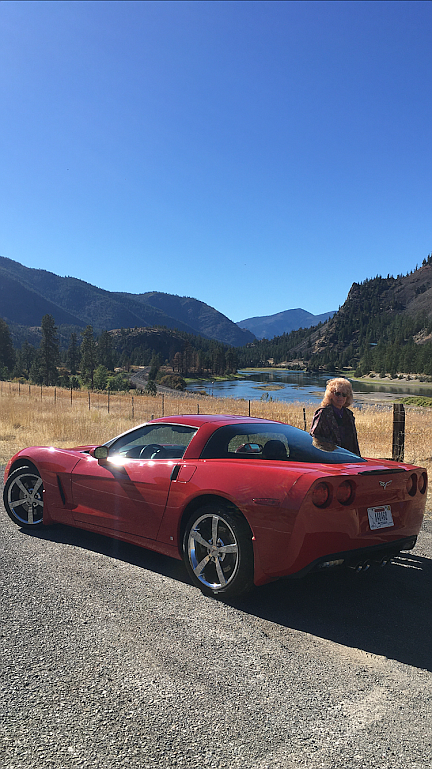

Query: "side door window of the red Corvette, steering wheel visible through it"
<box><xmin>105</xmin><ymin>423</ymin><xmax>197</xmax><ymax>459</ymax></box>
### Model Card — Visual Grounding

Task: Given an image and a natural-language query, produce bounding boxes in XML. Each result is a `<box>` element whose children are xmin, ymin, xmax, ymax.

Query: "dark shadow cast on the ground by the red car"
<box><xmin>21</xmin><ymin>525</ymin><xmax>432</xmax><ymax>671</ymax></box>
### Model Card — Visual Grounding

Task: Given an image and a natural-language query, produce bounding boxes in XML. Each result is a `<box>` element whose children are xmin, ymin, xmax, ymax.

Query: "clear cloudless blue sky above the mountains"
<box><xmin>0</xmin><ymin>0</ymin><xmax>432</xmax><ymax>321</ymax></box>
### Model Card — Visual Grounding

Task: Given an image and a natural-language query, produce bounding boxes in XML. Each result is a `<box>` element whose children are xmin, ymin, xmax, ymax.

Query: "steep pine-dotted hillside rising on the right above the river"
<box><xmin>238</xmin><ymin>255</ymin><xmax>432</xmax><ymax>376</ymax></box>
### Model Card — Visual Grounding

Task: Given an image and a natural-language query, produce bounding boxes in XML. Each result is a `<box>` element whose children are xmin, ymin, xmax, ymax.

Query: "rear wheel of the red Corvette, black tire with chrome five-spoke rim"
<box><xmin>183</xmin><ymin>505</ymin><xmax>253</xmax><ymax>598</ymax></box>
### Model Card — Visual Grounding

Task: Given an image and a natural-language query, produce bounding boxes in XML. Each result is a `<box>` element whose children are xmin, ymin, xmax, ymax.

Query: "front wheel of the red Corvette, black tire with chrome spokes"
<box><xmin>3</xmin><ymin>465</ymin><xmax>43</xmax><ymax>528</ymax></box>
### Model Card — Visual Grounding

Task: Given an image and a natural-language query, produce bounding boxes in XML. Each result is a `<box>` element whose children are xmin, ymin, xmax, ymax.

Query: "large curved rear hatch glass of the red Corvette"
<box><xmin>201</xmin><ymin>424</ymin><xmax>365</xmax><ymax>465</ymax></box>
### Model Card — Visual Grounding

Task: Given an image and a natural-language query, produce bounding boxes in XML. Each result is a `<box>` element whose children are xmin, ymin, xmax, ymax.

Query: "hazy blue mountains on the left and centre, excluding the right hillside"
<box><xmin>0</xmin><ymin>256</ymin><xmax>332</xmax><ymax>347</ymax></box>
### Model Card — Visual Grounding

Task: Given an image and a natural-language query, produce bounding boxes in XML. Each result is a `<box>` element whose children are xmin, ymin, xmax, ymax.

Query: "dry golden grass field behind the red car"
<box><xmin>0</xmin><ymin>382</ymin><xmax>432</xmax><ymax>510</ymax></box>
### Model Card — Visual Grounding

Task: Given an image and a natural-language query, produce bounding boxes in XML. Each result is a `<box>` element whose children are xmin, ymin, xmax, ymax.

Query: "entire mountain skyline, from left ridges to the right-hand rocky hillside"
<box><xmin>0</xmin><ymin>254</ymin><xmax>432</xmax><ymax>376</ymax></box>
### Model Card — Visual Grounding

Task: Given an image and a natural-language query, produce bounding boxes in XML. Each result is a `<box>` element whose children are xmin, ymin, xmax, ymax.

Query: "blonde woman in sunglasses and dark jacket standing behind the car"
<box><xmin>310</xmin><ymin>377</ymin><xmax>360</xmax><ymax>456</ymax></box>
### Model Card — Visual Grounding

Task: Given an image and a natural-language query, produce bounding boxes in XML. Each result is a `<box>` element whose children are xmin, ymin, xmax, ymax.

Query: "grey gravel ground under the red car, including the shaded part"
<box><xmin>0</xmin><ymin>464</ymin><xmax>432</xmax><ymax>769</ymax></box>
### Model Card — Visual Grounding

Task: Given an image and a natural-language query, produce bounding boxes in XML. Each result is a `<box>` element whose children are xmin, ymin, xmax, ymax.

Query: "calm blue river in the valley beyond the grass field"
<box><xmin>187</xmin><ymin>369</ymin><xmax>432</xmax><ymax>404</ymax></box>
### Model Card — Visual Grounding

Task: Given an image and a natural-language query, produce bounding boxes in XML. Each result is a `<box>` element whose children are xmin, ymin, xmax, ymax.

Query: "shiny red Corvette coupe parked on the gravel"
<box><xmin>4</xmin><ymin>415</ymin><xmax>427</xmax><ymax>597</ymax></box>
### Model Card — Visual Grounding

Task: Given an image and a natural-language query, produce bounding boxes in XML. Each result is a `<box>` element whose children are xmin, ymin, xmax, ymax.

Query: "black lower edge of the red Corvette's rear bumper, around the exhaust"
<box><xmin>285</xmin><ymin>535</ymin><xmax>417</xmax><ymax>579</ymax></box>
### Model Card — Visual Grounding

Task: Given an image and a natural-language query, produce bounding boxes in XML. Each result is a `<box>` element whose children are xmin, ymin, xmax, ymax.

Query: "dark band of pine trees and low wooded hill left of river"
<box><xmin>0</xmin><ymin>314</ymin><xmax>238</xmax><ymax>390</ymax></box>
